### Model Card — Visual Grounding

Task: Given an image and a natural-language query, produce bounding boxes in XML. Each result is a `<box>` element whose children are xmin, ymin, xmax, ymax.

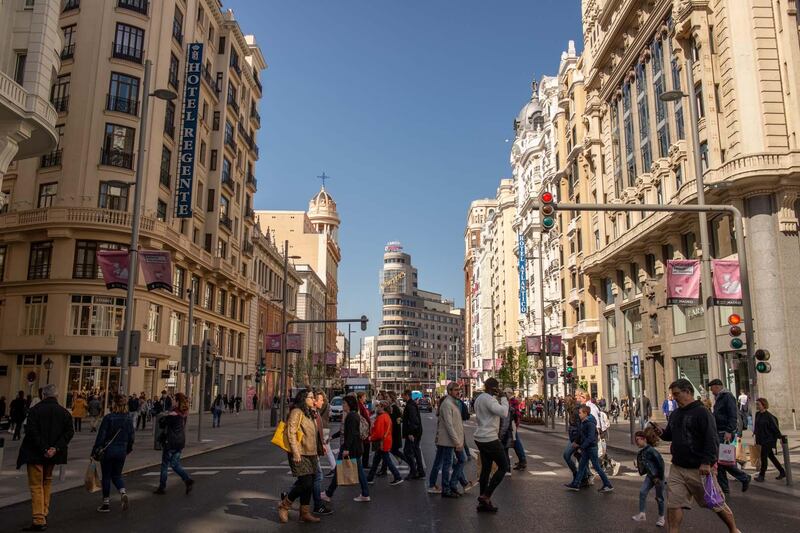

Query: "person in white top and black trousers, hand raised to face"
<box><xmin>473</xmin><ymin>378</ymin><xmax>509</xmax><ymax>513</ymax></box>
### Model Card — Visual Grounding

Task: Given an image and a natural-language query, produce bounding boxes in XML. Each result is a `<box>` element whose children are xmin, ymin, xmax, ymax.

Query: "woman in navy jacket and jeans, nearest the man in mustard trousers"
<box><xmin>92</xmin><ymin>395</ymin><xmax>136</xmax><ymax>513</ymax></box>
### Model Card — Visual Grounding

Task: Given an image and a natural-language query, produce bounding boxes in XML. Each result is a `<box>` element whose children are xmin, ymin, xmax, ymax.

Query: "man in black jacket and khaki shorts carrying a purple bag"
<box><xmin>656</xmin><ymin>378</ymin><xmax>738</xmax><ymax>533</ymax></box>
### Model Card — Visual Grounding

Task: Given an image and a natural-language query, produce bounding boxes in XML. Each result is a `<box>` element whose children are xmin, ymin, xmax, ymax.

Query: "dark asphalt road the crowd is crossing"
<box><xmin>0</xmin><ymin>414</ymin><xmax>800</xmax><ymax>533</ymax></box>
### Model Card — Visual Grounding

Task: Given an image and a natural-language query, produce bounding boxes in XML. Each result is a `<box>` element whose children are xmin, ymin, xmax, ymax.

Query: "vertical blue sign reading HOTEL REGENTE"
<box><xmin>175</xmin><ymin>43</ymin><xmax>203</xmax><ymax>218</ymax></box>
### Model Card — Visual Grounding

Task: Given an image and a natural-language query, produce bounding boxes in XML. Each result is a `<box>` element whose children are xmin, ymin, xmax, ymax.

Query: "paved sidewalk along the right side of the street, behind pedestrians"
<box><xmin>520</xmin><ymin>419</ymin><xmax>800</xmax><ymax>498</ymax></box>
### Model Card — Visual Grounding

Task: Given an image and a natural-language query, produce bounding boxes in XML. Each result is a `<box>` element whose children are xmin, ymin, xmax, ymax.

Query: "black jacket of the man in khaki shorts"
<box><xmin>661</xmin><ymin>400</ymin><xmax>719</xmax><ymax>468</ymax></box>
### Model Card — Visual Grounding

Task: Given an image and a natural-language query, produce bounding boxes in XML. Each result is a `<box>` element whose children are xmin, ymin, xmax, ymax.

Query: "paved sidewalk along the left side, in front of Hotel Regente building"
<box><xmin>0</xmin><ymin>411</ymin><xmax>274</xmax><ymax>507</ymax></box>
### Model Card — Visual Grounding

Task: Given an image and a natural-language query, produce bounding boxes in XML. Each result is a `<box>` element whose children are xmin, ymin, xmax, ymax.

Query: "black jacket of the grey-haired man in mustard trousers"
<box><xmin>17</xmin><ymin>398</ymin><xmax>75</xmax><ymax>468</ymax></box>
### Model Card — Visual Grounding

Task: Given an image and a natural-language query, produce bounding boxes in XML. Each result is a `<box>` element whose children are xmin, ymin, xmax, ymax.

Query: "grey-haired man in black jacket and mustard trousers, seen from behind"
<box><xmin>17</xmin><ymin>384</ymin><xmax>75</xmax><ymax>531</ymax></box>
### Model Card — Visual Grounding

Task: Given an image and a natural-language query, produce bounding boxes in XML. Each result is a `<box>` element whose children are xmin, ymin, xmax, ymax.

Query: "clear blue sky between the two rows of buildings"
<box><xmin>223</xmin><ymin>0</ymin><xmax>581</xmax><ymax>353</ymax></box>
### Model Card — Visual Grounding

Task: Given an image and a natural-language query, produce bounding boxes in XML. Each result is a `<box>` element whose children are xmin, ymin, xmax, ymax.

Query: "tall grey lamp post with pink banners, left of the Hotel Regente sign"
<box><xmin>120</xmin><ymin>59</ymin><xmax>178</xmax><ymax>396</ymax></box>
